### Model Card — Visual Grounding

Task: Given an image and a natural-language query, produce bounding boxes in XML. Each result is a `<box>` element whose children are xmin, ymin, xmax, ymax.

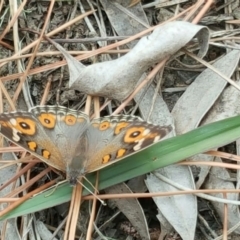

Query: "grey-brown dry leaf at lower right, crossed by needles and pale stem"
<box><xmin>203</xmin><ymin>158</ymin><xmax>240</xmax><ymax>234</ymax></box>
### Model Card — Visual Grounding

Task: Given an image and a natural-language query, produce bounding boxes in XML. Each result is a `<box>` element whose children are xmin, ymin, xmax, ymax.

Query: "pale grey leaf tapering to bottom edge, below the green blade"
<box><xmin>146</xmin><ymin>172</ymin><xmax>197</xmax><ymax>240</ymax></box>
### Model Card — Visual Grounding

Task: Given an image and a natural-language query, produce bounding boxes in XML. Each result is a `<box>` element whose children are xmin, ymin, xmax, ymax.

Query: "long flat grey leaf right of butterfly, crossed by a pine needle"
<box><xmin>172</xmin><ymin>50</ymin><xmax>240</xmax><ymax>134</ymax></box>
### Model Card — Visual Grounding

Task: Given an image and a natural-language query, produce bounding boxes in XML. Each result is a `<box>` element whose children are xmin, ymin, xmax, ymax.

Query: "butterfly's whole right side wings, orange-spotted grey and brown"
<box><xmin>67</xmin><ymin>115</ymin><xmax>171</xmax><ymax>178</ymax></box>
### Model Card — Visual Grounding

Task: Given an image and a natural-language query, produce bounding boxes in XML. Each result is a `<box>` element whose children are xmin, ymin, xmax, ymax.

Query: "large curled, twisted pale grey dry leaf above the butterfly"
<box><xmin>51</xmin><ymin>21</ymin><xmax>209</xmax><ymax>101</ymax></box>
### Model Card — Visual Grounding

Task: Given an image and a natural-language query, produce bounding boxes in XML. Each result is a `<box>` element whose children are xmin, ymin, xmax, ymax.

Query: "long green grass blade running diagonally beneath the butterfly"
<box><xmin>0</xmin><ymin>116</ymin><xmax>240</xmax><ymax>220</ymax></box>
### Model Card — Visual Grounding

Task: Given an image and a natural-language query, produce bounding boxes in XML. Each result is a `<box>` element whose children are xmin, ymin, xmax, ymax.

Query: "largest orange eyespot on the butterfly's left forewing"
<box><xmin>9</xmin><ymin>117</ymin><xmax>36</xmax><ymax>135</ymax></box>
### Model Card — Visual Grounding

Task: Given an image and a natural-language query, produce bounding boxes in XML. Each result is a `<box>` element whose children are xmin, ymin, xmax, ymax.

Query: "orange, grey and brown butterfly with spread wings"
<box><xmin>0</xmin><ymin>106</ymin><xmax>172</xmax><ymax>185</ymax></box>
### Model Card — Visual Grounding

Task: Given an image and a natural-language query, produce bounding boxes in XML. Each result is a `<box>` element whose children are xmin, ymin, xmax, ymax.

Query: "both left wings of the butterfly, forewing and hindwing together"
<box><xmin>0</xmin><ymin>106</ymin><xmax>89</xmax><ymax>171</ymax></box>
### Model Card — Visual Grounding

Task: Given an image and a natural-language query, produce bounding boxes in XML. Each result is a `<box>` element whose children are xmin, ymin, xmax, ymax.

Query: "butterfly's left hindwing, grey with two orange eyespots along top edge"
<box><xmin>31</xmin><ymin>106</ymin><xmax>89</xmax><ymax>171</ymax></box>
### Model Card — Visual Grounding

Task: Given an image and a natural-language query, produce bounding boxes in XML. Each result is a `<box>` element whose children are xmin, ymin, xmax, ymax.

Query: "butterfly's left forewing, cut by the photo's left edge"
<box><xmin>0</xmin><ymin>109</ymin><xmax>64</xmax><ymax>170</ymax></box>
